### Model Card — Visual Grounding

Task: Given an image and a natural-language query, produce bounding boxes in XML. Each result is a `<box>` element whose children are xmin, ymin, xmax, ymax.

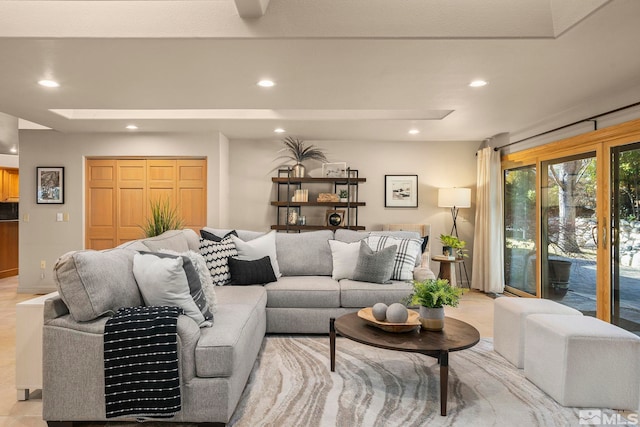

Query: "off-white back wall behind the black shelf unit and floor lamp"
<box><xmin>227</xmin><ymin>140</ymin><xmax>480</xmax><ymax>277</ymax></box>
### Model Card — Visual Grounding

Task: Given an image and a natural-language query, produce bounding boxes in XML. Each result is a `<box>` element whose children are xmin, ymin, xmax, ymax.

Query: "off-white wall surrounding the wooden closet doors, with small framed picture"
<box><xmin>18</xmin><ymin>130</ymin><xmax>226</xmax><ymax>293</ymax></box>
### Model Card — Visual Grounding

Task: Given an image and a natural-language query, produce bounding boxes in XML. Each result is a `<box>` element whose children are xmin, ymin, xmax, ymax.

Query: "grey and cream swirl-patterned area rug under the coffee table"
<box><xmin>229</xmin><ymin>336</ymin><xmax>613</xmax><ymax>427</ymax></box>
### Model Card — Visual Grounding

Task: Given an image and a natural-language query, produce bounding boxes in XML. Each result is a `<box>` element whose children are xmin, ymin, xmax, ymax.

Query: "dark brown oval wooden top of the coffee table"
<box><xmin>335</xmin><ymin>313</ymin><xmax>480</xmax><ymax>355</ymax></box>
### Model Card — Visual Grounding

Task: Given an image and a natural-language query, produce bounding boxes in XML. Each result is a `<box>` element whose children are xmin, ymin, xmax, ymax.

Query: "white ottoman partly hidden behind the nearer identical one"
<box><xmin>493</xmin><ymin>297</ymin><xmax>582</xmax><ymax>369</ymax></box>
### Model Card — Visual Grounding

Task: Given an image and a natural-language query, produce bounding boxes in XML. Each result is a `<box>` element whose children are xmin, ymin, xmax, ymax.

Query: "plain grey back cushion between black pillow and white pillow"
<box><xmin>276</xmin><ymin>230</ymin><xmax>333</xmax><ymax>276</ymax></box>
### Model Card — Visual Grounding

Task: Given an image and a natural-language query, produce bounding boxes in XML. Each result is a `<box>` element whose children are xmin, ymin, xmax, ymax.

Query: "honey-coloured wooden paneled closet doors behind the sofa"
<box><xmin>85</xmin><ymin>158</ymin><xmax>207</xmax><ymax>250</ymax></box>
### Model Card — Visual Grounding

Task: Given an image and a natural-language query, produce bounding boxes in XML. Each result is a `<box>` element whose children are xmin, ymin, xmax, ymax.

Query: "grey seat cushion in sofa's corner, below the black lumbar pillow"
<box><xmin>264</xmin><ymin>276</ymin><xmax>340</xmax><ymax>308</ymax></box>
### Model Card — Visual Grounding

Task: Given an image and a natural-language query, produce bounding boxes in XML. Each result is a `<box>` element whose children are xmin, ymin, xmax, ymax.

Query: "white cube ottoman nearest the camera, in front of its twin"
<box><xmin>524</xmin><ymin>314</ymin><xmax>640</xmax><ymax>411</ymax></box>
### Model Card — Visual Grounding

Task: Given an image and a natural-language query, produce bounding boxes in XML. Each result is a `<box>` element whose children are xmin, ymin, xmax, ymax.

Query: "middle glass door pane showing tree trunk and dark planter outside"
<box><xmin>540</xmin><ymin>152</ymin><xmax>598</xmax><ymax>316</ymax></box>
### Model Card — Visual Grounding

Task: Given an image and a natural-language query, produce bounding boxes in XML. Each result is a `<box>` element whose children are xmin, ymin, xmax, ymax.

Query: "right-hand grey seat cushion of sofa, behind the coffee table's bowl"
<box><xmin>340</xmin><ymin>279</ymin><xmax>413</xmax><ymax>308</ymax></box>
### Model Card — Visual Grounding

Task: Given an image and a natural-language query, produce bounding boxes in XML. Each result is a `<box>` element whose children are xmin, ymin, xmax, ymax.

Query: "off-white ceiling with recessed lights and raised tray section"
<box><xmin>0</xmin><ymin>0</ymin><xmax>640</xmax><ymax>153</ymax></box>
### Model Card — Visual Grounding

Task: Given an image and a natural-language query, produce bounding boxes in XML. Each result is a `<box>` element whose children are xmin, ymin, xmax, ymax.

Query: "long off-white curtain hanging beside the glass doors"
<box><xmin>471</xmin><ymin>147</ymin><xmax>504</xmax><ymax>293</ymax></box>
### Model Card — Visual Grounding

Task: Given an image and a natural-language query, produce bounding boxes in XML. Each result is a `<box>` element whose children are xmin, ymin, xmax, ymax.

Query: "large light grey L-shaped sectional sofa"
<box><xmin>43</xmin><ymin>229</ymin><xmax>434</xmax><ymax>425</ymax></box>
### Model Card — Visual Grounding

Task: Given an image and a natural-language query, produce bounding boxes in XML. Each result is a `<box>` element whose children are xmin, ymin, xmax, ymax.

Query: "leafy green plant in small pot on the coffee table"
<box><xmin>407</xmin><ymin>279</ymin><xmax>462</xmax><ymax>331</ymax></box>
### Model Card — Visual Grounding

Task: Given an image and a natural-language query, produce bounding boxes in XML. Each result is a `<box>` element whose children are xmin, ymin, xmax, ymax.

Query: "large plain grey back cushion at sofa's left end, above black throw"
<box><xmin>53</xmin><ymin>249</ymin><xmax>142</xmax><ymax>322</ymax></box>
